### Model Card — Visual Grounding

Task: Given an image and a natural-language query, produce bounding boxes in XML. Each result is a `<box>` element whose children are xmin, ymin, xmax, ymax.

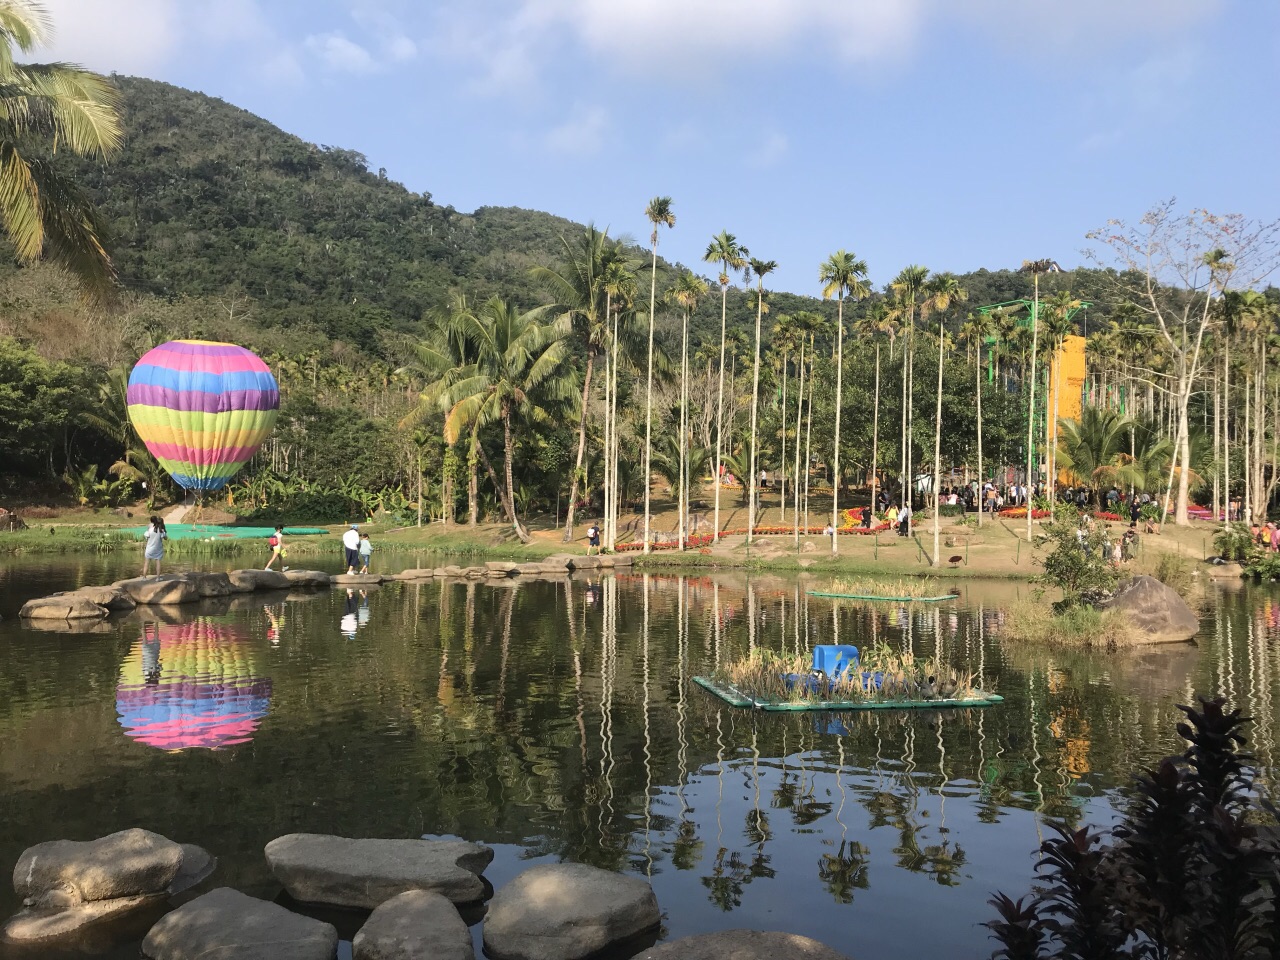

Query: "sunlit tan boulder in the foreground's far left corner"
<box><xmin>13</xmin><ymin>827</ymin><xmax>183</xmax><ymax>905</ymax></box>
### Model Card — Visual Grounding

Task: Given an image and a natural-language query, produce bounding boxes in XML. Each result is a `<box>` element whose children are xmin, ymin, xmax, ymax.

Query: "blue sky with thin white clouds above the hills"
<box><xmin>38</xmin><ymin>0</ymin><xmax>1280</xmax><ymax>293</ymax></box>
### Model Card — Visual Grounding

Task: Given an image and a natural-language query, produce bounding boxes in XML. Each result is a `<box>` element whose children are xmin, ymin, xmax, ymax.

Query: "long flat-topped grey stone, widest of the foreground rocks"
<box><xmin>266</xmin><ymin>833</ymin><xmax>493</xmax><ymax>910</ymax></box>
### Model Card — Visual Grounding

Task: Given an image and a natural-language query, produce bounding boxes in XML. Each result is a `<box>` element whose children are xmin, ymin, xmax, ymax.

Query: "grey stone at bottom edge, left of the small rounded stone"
<box><xmin>142</xmin><ymin>887</ymin><xmax>338</xmax><ymax>960</ymax></box>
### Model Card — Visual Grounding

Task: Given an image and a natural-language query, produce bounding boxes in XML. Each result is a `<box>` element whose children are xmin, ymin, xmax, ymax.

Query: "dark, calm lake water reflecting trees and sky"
<box><xmin>0</xmin><ymin>557</ymin><xmax>1280</xmax><ymax>960</ymax></box>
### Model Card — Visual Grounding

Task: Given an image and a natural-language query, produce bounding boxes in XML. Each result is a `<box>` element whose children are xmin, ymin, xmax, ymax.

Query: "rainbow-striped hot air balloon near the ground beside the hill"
<box><xmin>128</xmin><ymin>340</ymin><xmax>280</xmax><ymax>490</ymax></box>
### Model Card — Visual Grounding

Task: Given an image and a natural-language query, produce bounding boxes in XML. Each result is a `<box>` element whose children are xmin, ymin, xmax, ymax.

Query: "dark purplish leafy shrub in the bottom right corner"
<box><xmin>986</xmin><ymin>699</ymin><xmax>1280</xmax><ymax>960</ymax></box>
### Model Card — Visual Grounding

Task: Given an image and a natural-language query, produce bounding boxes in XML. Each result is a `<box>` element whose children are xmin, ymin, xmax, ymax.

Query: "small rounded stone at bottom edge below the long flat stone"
<box><xmin>351</xmin><ymin>890</ymin><xmax>475</xmax><ymax>960</ymax></box>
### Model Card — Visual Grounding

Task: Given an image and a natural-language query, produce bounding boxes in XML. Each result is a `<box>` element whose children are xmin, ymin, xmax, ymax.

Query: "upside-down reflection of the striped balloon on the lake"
<box><xmin>115</xmin><ymin>618</ymin><xmax>271</xmax><ymax>750</ymax></box>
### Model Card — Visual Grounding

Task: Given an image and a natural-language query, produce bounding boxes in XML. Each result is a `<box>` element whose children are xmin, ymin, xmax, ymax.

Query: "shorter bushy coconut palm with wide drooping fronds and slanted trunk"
<box><xmin>442</xmin><ymin>297</ymin><xmax>576</xmax><ymax>543</ymax></box>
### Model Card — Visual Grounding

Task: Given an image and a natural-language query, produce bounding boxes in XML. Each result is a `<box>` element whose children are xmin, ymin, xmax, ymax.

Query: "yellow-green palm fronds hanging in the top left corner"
<box><xmin>0</xmin><ymin>0</ymin><xmax>124</xmax><ymax>297</ymax></box>
